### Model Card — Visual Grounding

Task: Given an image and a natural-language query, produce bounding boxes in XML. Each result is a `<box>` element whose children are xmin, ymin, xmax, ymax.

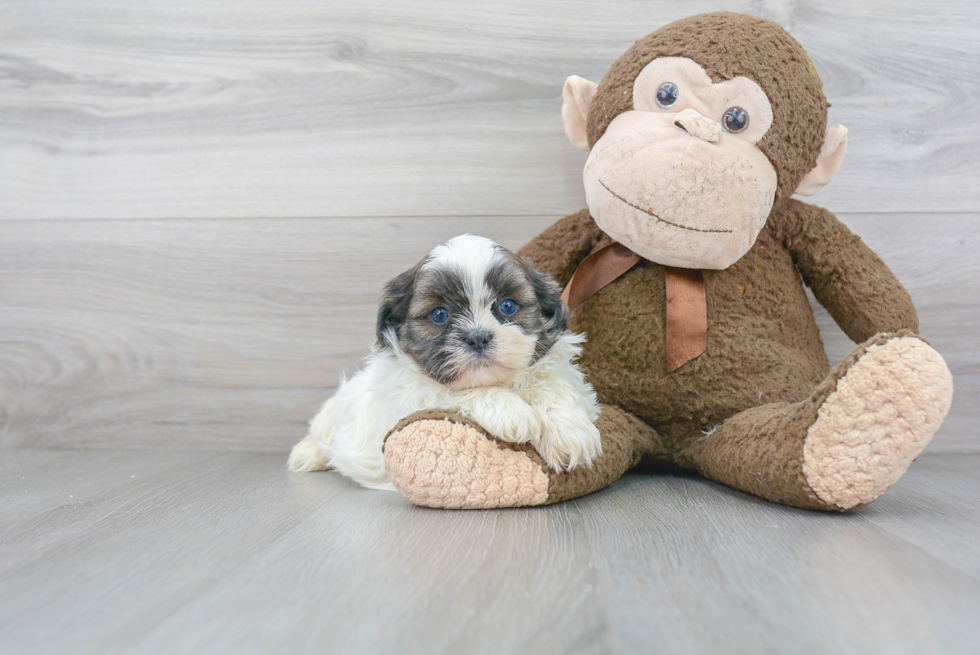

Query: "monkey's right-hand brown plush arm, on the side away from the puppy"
<box><xmin>773</xmin><ymin>200</ymin><xmax>919</xmax><ymax>343</ymax></box>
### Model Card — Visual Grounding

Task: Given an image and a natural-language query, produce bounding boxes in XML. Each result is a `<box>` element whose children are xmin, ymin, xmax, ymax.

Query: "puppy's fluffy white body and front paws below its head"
<box><xmin>289</xmin><ymin>333</ymin><xmax>601</xmax><ymax>490</ymax></box>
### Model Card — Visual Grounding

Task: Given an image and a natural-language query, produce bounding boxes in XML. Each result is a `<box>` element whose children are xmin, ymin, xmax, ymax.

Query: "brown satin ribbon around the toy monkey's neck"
<box><xmin>561</xmin><ymin>241</ymin><xmax>708</xmax><ymax>373</ymax></box>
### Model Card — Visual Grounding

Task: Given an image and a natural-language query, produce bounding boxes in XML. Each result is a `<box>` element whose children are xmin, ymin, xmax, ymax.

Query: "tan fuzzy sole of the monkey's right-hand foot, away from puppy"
<box><xmin>803</xmin><ymin>336</ymin><xmax>953</xmax><ymax>509</ymax></box>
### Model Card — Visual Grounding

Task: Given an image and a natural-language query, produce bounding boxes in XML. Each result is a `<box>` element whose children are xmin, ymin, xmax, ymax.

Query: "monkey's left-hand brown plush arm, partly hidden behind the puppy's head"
<box><xmin>517</xmin><ymin>209</ymin><xmax>602</xmax><ymax>287</ymax></box>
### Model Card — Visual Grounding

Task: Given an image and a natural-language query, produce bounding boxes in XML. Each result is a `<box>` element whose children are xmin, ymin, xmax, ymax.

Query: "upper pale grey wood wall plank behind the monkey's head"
<box><xmin>0</xmin><ymin>0</ymin><xmax>980</xmax><ymax>219</ymax></box>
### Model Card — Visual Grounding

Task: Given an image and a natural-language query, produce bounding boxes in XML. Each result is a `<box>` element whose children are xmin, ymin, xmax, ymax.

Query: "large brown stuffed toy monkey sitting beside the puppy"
<box><xmin>384</xmin><ymin>12</ymin><xmax>952</xmax><ymax>511</ymax></box>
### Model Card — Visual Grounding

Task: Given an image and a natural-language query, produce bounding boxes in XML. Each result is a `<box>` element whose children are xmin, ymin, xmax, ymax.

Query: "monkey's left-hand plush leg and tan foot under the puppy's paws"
<box><xmin>384</xmin><ymin>406</ymin><xmax>663</xmax><ymax>509</ymax></box>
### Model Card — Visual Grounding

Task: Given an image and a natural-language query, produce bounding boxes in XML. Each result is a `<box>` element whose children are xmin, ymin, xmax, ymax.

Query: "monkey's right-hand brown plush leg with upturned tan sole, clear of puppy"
<box><xmin>677</xmin><ymin>332</ymin><xmax>953</xmax><ymax>511</ymax></box>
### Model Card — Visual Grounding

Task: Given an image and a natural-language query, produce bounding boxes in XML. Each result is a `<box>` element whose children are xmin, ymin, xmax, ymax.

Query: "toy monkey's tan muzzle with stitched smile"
<box><xmin>583</xmin><ymin>109</ymin><xmax>776</xmax><ymax>269</ymax></box>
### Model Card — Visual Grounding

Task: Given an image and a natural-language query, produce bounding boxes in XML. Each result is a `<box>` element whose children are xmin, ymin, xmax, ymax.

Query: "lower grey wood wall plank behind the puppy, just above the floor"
<box><xmin>0</xmin><ymin>215</ymin><xmax>980</xmax><ymax>452</ymax></box>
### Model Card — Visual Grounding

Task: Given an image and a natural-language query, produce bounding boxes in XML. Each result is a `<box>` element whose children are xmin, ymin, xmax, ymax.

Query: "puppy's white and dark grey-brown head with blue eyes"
<box><xmin>378</xmin><ymin>234</ymin><xmax>567</xmax><ymax>389</ymax></box>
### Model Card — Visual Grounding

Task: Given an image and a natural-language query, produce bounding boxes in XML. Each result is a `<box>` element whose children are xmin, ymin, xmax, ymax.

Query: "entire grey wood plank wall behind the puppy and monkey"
<box><xmin>0</xmin><ymin>0</ymin><xmax>980</xmax><ymax>452</ymax></box>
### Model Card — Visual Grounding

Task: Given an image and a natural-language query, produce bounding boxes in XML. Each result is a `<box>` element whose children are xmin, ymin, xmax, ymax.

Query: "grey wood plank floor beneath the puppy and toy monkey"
<box><xmin>0</xmin><ymin>449</ymin><xmax>980</xmax><ymax>655</ymax></box>
